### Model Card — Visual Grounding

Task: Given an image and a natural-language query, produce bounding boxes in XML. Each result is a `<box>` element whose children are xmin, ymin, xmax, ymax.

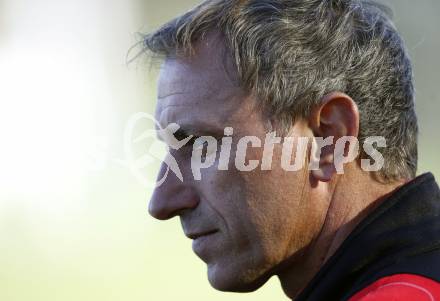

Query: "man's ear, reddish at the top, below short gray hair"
<box><xmin>308</xmin><ymin>92</ymin><xmax>359</xmax><ymax>182</ymax></box>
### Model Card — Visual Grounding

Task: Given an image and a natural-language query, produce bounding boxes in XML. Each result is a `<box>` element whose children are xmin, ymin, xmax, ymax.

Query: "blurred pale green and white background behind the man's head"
<box><xmin>0</xmin><ymin>0</ymin><xmax>440</xmax><ymax>301</ymax></box>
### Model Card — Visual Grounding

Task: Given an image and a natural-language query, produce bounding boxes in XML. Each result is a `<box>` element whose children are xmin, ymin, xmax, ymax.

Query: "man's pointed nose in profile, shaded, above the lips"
<box><xmin>148</xmin><ymin>164</ymin><xmax>199</xmax><ymax>220</ymax></box>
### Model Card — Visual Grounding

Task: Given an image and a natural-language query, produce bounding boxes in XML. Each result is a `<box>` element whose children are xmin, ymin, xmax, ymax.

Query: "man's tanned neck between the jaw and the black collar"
<box><xmin>278</xmin><ymin>171</ymin><xmax>404</xmax><ymax>300</ymax></box>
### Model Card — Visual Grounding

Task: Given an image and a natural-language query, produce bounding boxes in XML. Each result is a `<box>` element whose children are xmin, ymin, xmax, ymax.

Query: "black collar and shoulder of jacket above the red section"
<box><xmin>295</xmin><ymin>173</ymin><xmax>440</xmax><ymax>301</ymax></box>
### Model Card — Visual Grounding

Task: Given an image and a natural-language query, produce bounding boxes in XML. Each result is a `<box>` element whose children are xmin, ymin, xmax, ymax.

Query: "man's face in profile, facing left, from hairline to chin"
<box><xmin>150</xmin><ymin>42</ymin><xmax>323</xmax><ymax>291</ymax></box>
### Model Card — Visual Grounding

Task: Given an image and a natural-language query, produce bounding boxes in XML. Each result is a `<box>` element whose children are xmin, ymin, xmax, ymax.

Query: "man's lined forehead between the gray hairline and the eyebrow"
<box><xmin>156</xmin><ymin>39</ymin><xmax>244</xmax><ymax>134</ymax></box>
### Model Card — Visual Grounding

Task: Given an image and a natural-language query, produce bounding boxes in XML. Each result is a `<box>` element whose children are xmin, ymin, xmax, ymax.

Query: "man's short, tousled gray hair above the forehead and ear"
<box><xmin>143</xmin><ymin>0</ymin><xmax>418</xmax><ymax>182</ymax></box>
